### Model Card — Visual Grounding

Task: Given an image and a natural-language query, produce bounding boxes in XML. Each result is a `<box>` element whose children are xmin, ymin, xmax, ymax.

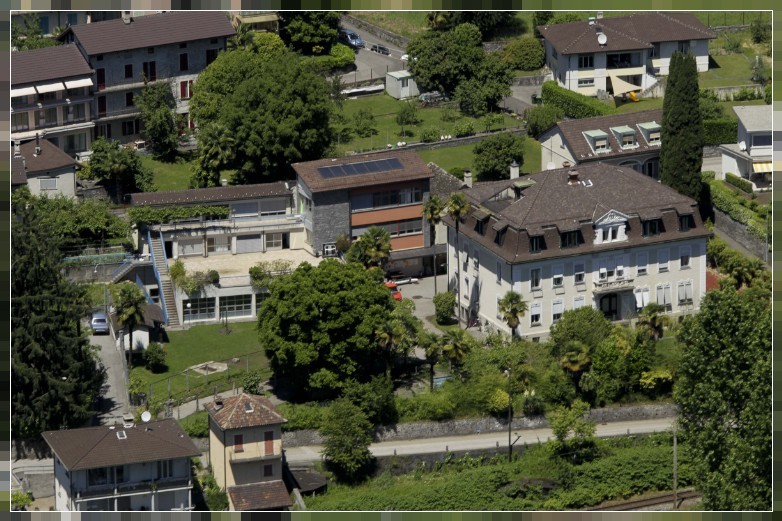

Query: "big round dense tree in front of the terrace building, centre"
<box><xmin>258</xmin><ymin>260</ymin><xmax>394</xmax><ymax>399</ymax></box>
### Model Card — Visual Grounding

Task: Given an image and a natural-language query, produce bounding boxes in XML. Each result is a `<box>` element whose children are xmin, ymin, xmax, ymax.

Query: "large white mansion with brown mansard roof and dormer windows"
<box><xmin>445</xmin><ymin>163</ymin><xmax>711</xmax><ymax>340</ymax></box>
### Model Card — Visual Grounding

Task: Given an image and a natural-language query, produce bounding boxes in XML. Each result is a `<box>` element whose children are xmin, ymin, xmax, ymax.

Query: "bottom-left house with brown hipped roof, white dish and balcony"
<box><xmin>43</xmin><ymin>419</ymin><xmax>201</xmax><ymax>511</ymax></box>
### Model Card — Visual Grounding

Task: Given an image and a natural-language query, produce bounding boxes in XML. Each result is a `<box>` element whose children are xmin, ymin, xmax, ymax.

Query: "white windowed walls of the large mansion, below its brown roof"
<box><xmin>448</xmin><ymin>222</ymin><xmax>706</xmax><ymax>339</ymax></box>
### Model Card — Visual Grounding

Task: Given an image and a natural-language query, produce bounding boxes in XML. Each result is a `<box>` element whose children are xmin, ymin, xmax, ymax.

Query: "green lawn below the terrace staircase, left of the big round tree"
<box><xmin>131</xmin><ymin>321</ymin><xmax>269</xmax><ymax>406</ymax></box>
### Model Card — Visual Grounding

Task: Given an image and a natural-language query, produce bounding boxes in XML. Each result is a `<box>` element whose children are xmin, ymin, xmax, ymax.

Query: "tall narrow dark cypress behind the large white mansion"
<box><xmin>660</xmin><ymin>52</ymin><xmax>703</xmax><ymax>201</ymax></box>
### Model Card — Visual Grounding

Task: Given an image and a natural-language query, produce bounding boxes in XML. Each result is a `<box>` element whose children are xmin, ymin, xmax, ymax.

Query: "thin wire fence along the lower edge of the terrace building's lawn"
<box><xmin>140</xmin><ymin>350</ymin><xmax>271</xmax><ymax>417</ymax></box>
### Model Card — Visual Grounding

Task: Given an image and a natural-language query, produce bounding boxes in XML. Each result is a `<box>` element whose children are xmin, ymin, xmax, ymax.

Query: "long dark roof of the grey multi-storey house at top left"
<box><xmin>60</xmin><ymin>11</ymin><xmax>236</xmax><ymax>56</ymax></box>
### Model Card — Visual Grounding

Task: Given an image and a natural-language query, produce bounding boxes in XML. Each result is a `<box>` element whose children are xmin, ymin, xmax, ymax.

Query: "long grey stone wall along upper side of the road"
<box><xmin>282</xmin><ymin>404</ymin><xmax>676</xmax><ymax>447</ymax></box>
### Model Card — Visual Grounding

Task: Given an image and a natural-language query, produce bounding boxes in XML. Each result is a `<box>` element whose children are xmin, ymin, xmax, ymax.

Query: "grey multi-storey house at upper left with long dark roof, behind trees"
<box><xmin>58</xmin><ymin>11</ymin><xmax>235</xmax><ymax>143</ymax></box>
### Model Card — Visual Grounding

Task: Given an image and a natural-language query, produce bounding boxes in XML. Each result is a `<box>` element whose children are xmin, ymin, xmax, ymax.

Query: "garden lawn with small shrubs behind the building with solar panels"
<box><xmin>337</xmin><ymin>94</ymin><xmax>521</xmax><ymax>156</ymax></box>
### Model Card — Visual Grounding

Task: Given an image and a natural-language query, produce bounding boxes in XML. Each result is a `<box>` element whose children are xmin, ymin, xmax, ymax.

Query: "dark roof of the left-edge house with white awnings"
<box><xmin>11</xmin><ymin>44</ymin><xmax>92</xmax><ymax>86</ymax></box>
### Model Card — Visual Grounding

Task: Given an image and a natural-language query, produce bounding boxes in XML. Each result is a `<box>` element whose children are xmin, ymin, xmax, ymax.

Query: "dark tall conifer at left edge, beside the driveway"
<box><xmin>11</xmin><ymin>201</ymin><xmax>104</xmax><ymax>439</ymax></box>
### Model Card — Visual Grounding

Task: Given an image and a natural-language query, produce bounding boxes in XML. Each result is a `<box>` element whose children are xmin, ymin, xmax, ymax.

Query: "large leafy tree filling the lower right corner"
<box><xmin>674</xmin><ymin>287</ymin><xmax>772</xmax><ymax>510</ymax></box>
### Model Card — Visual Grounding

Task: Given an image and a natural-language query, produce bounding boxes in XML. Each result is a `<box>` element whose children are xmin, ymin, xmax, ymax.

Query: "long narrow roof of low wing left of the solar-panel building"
<box><xmin>130</xmin><ymin>181</ymin><xmax>293</xmax><ymax>206</ymax></box>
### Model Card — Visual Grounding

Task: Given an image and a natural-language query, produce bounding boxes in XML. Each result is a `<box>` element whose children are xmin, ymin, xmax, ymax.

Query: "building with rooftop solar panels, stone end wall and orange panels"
<box><xmin>293</xmin><ymin>150</ymin><xmax>434</xmax><ymax>275</ymax></box>
